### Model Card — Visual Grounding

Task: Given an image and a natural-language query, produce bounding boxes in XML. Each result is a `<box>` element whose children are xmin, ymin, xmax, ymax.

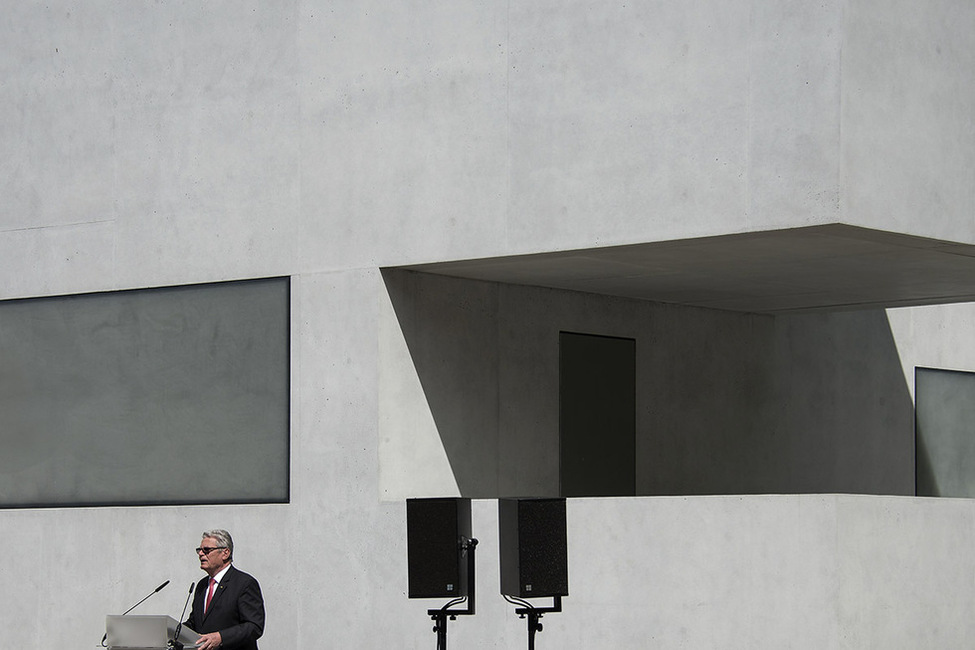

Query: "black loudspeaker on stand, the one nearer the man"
<box><xmin>406</xmin><ymin>498</ymin><xmax>471</xmax><ymax>598</ymax></box>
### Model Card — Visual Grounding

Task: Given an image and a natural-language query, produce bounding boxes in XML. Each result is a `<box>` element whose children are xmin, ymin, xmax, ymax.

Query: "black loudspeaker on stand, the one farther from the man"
<box><xmin>498</xmin><ymin>499</ymin><xmax>569</xmax><ymax>598</ymax></box>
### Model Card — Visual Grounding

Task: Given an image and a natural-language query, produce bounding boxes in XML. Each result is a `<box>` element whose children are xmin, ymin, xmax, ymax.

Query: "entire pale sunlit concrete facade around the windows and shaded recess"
<box><xmin>0</xmin><ymin>0</ymin><xmax>975</xmax><ymax>648</ymax></box>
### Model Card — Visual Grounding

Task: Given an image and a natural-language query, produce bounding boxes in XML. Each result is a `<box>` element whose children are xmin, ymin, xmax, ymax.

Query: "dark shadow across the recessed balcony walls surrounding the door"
<box><xmin>383</xmin><ymin>269</ymin><xmax>915</xmax><ymax>498</ymax></box>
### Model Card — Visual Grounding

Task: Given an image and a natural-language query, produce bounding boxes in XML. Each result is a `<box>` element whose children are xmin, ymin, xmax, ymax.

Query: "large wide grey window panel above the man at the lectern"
<box><xmin>0</xmin><ymin>278</ymin><xmax>290</xmax><ymax>508</ymax></box>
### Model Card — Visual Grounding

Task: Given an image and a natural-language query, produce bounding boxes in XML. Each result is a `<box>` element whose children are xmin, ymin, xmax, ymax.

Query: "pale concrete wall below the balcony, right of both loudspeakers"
<box><xmin>564</xmin><ymin>496</ymin><xmax>972</xmax><ymax>649</ymax></box>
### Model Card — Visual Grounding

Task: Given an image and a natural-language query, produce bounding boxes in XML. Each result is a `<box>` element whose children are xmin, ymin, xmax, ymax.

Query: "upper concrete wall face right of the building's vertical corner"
<box><xmin>839</xmin><ymin>0</ymin><xmax>975</xmax><ymax>242</ymax></box>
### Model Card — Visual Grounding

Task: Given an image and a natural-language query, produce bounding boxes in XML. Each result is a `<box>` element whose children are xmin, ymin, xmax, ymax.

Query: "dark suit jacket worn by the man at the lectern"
<box><xmin>183</xmin><ymin>565</ymin><xmax>264</xmax><ymax>650</ymax></box>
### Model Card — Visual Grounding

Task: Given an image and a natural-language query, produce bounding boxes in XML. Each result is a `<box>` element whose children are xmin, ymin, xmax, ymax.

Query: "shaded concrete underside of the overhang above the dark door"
<box><xmin>399</xmin><ymin>224</ymin><xmax>975</xmax><ymax>314</ymax></box>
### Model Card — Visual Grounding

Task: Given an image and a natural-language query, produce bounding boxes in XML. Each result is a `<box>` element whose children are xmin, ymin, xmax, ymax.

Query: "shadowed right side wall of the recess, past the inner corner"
<box><xmin>769</xmin><ymin>310</ymin><xmax>915</xmax><ymax>495</ymax></box>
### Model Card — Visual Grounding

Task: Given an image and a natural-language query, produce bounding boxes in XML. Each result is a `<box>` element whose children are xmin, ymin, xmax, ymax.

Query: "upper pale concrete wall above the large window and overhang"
<box><xmin>13</xmin><ymin>0</ymin><xmax>975</xmax><ymax>296</ymax></box>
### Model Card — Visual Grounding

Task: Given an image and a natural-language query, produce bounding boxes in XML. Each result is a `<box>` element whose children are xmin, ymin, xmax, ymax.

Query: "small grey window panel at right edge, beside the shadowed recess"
<box><xmin>914</xmin><ymin>368</ymin><xmax>975</xmax><ymax>498</ymax></box>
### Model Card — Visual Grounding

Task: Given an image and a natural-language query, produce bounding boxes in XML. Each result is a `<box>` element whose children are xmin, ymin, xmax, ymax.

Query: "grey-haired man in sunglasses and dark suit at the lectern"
<box><xmin>183</xmin><ymin>530</ymin><xmax>264</xmax><ymax>650</ymax></box>
